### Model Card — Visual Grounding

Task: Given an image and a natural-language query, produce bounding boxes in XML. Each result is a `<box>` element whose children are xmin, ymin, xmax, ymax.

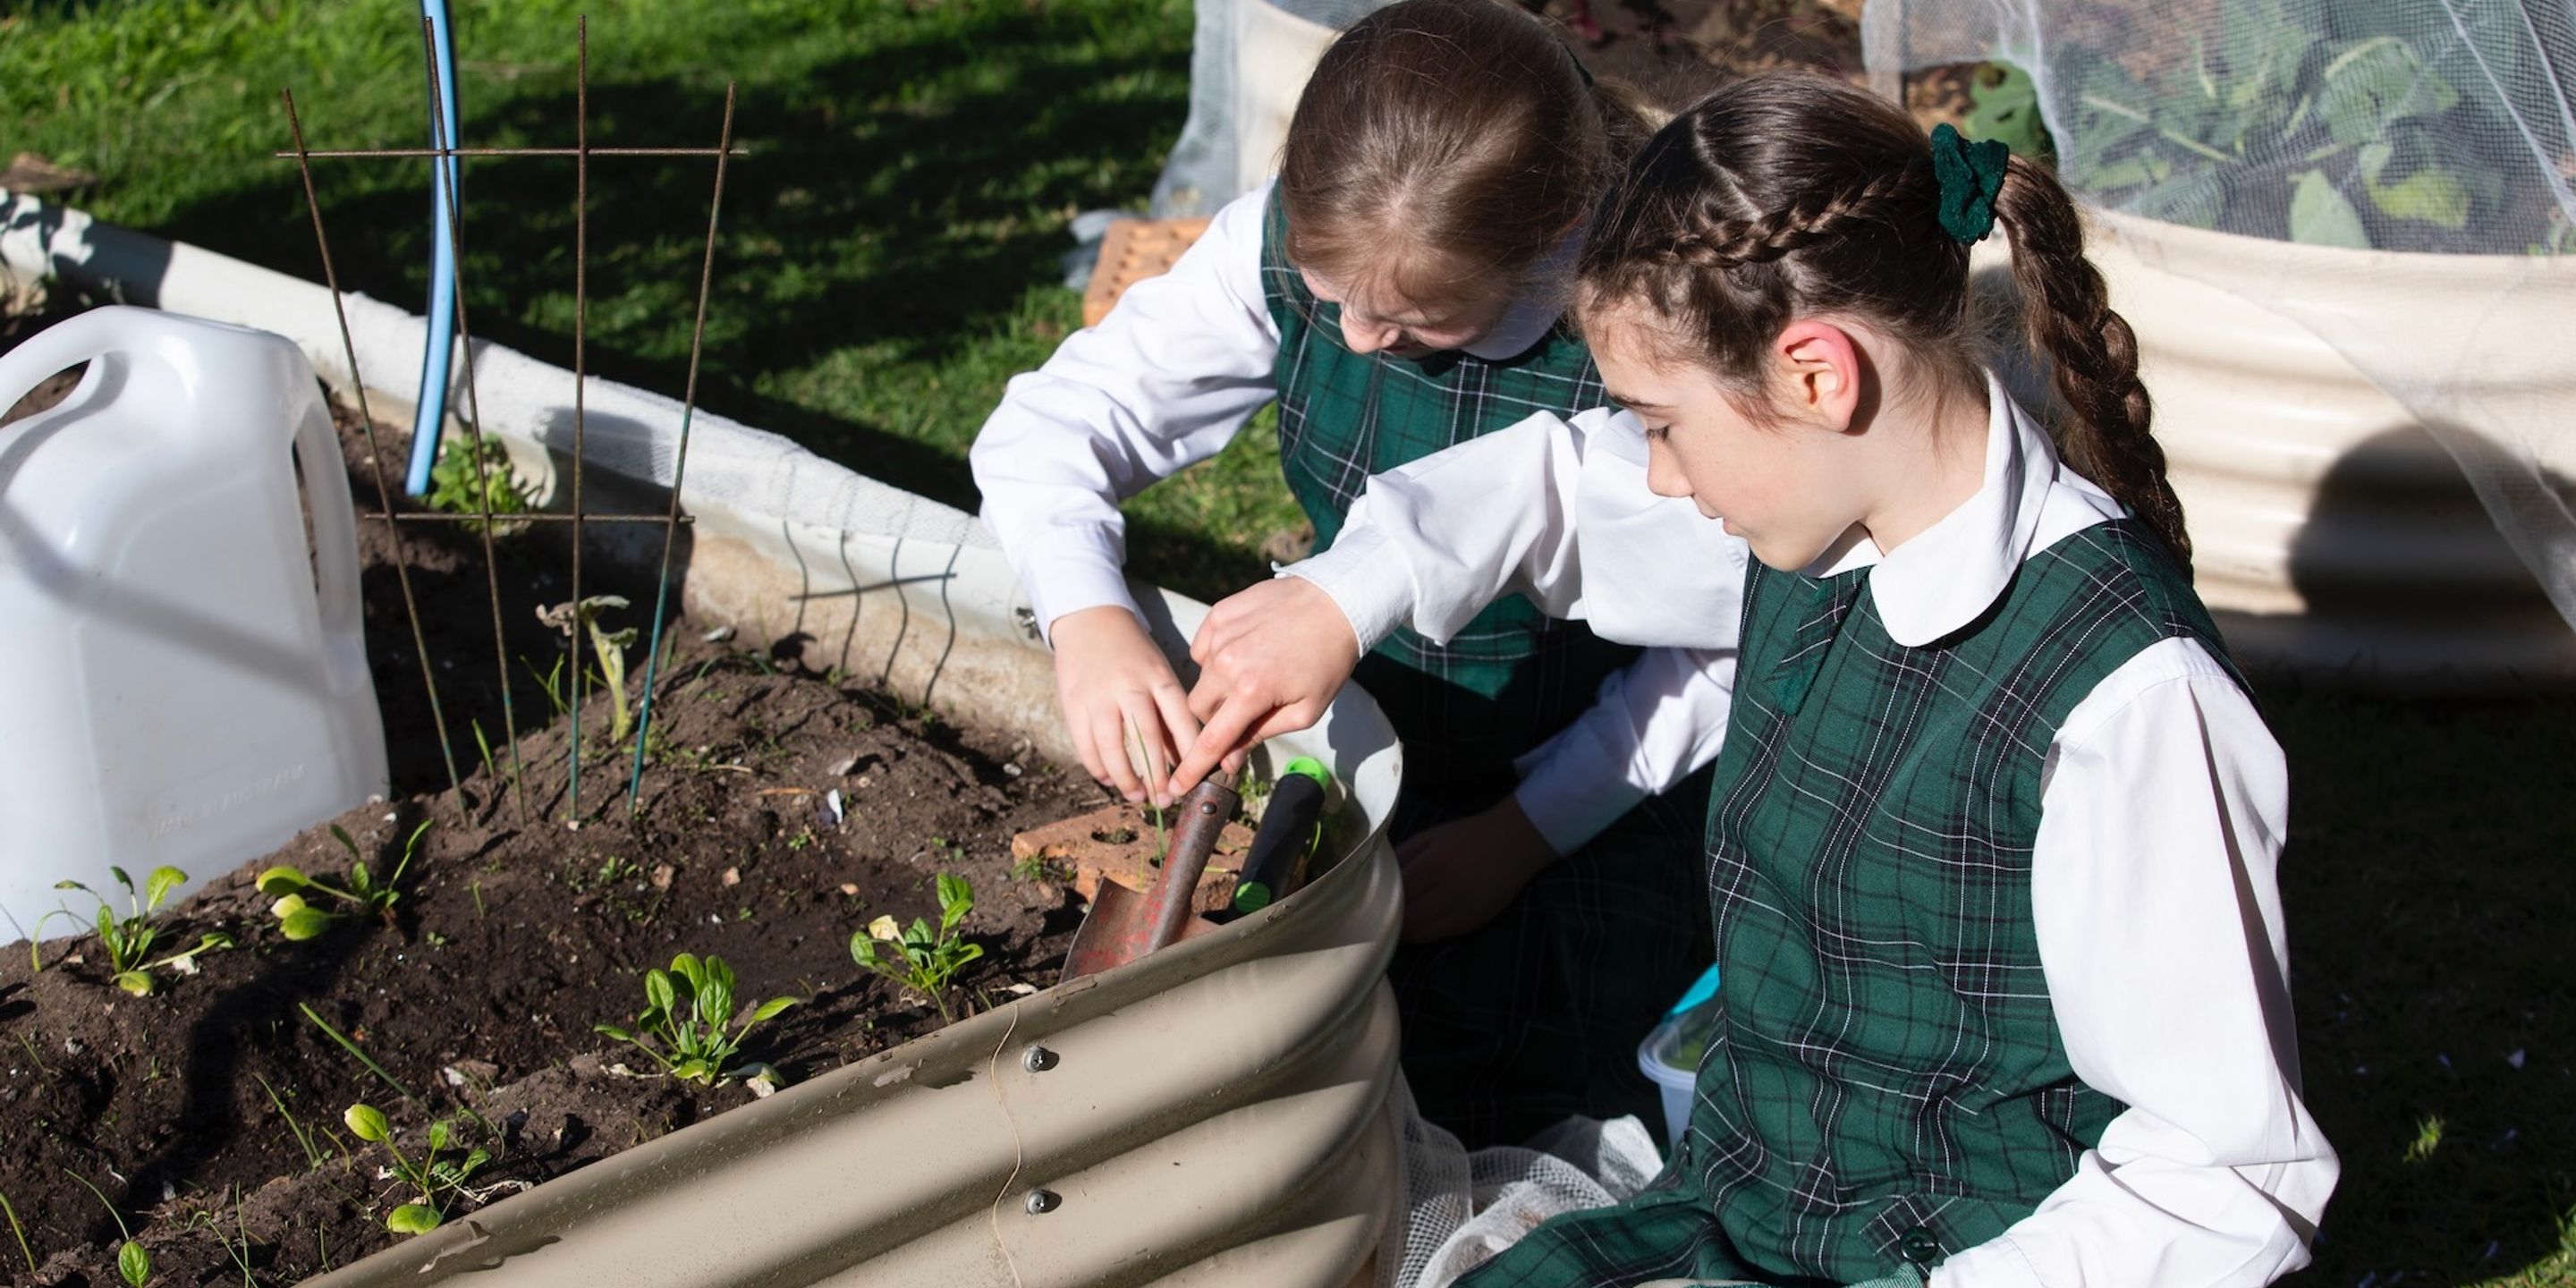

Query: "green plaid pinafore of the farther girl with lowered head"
<box><xmin>1262</xmin><ymin>193</ymin><xmax>1639</xmax><ymax>809</ymax></box>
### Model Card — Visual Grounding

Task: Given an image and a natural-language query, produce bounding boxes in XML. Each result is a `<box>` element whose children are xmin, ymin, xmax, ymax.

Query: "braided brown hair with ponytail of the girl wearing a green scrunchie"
<box><xmin>1577</xmin><ymin>72</ymin><xmax>2192</xmax><ymax>564</ymax></box>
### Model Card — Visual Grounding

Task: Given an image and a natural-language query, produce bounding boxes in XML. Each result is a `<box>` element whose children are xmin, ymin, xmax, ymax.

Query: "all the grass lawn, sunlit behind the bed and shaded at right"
<box><xmin>0</xmin><ymin>0</ymin><xmax>2576</xmax><ymax>1288</ymax></box>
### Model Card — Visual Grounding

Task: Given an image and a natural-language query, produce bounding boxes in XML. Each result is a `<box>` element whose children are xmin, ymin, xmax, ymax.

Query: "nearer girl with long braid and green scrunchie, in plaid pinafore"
<box><xmin>1172</xmin><ymin>67</ymin><xmax>2336</xmax><ymax>1288</ymax></box>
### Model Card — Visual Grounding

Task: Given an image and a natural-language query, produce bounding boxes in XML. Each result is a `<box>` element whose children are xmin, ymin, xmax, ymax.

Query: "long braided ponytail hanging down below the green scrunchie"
<box><xmin>1994</xmin><ymin>157</ymin><xmax>2192</xmax><ymax>567</ymax></box>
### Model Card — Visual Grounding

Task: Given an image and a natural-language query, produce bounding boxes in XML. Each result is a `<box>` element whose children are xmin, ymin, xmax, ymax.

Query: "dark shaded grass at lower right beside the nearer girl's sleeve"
<box><xmin>2265</xmin><ymin>682</ymin><xmax>2576</xmax><ymax>1288</ymax></box>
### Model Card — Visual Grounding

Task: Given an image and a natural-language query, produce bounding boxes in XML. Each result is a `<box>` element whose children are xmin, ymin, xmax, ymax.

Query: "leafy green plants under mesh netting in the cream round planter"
<box><xmin>1862</xmin><ymin>0</ymin><xmax>2576</xmax><ymax>255</ymax></box>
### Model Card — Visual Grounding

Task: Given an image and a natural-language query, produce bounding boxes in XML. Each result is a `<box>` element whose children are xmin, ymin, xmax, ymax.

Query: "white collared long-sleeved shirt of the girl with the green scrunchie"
<box><xmin>1285</xmin><ymin>381</ymin><xmax>2339</xmax><ymax>1288</ymax></box>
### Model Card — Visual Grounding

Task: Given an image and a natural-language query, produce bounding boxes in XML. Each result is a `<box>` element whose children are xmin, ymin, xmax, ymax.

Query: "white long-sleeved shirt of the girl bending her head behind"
<box><xmin>969</xmin><ymin>185</ymin><xmax>1733</xmax><ymax>852</ymax></box>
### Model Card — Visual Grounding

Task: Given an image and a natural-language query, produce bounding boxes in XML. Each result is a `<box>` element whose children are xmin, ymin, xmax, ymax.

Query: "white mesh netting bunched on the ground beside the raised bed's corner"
<box><xmin>1378</xmin><ymin>1074</ymin><xmax>1664</xmax><ymax>1288</ymax></box>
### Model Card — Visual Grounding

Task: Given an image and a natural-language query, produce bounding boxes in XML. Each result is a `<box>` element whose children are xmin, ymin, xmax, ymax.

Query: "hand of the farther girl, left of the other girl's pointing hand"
<box><xmin>1048</xmin><ymin>606</ymin><xmax>1198</xmax><ymax>806</ymax></box>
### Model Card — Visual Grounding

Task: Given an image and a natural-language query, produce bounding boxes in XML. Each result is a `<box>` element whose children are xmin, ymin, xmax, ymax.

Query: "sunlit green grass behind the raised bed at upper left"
<box><xmin>0</xmin><ymin>0</ymin><xmax>1299</xmax><ymax>597</ymax></box>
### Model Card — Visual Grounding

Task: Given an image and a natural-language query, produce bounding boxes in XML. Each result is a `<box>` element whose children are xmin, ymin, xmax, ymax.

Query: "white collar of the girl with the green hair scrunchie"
<box><xmin>1806</xmin><ymin>371</ymin><xmax>2128</xmax><ymax>649</ymax></box>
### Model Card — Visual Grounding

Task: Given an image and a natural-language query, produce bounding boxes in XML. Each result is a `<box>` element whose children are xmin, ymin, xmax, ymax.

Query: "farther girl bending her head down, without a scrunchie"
<box><xmin>971</xmin><ymin>0</ymin><xmax>1726</xmax><ymax>1144</ymax></box>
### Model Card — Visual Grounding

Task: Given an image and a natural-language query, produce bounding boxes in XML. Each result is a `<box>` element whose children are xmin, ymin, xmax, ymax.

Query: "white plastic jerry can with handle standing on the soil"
<box><xmin>0</xmin><ymin>307</ymin><xmax>386</xmax><ymax>937</ymax></box>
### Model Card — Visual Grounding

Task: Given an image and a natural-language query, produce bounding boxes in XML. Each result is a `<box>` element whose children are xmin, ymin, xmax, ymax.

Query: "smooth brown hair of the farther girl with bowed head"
<box><xmin>1280</xmin><ymin>0</ymin><xmax>1662</xmax><ymax>301</ymax></box>
